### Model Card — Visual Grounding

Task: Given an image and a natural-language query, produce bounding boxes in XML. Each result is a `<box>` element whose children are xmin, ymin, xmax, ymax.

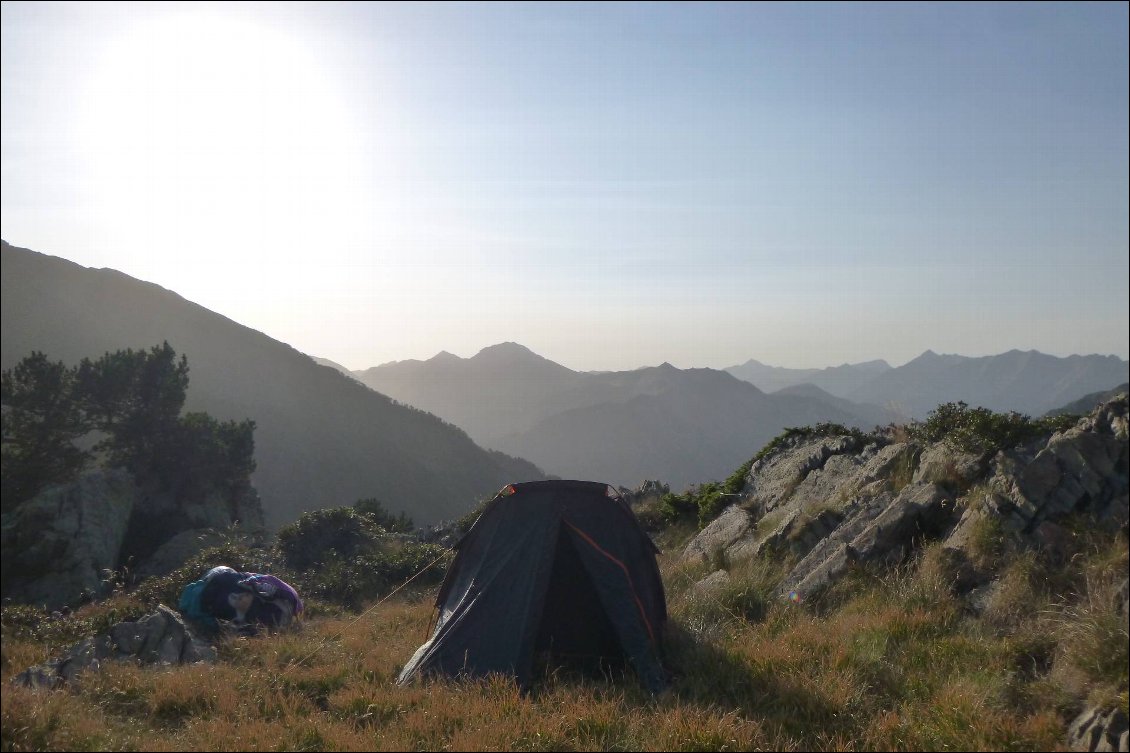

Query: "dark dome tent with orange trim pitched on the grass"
<box><xmin>398</xmin><ymin>481</ymin><xmax>667</xmax><ymax>693</ymax></box>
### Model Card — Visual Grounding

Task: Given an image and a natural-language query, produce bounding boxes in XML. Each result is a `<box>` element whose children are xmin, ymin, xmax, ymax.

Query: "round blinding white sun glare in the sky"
<box><xmin>78</xmin><ymin>9</ymin><xmax>362</xmax><ymax>287</ymax></box>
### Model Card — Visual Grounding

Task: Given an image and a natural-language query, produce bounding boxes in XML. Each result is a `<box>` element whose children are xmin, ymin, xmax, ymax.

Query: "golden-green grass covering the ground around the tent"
<box><xmin>0</xmin><ymin>526</ymin><xmax>1128</xmax><ymax>751</ymax></box>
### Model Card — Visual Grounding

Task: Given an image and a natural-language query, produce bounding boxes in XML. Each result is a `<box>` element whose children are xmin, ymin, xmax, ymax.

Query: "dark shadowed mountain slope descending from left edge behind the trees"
<box><xmin>0</xmin><ymin>242</ymin><xmax>545</xmax><ymax>526</ymax></box>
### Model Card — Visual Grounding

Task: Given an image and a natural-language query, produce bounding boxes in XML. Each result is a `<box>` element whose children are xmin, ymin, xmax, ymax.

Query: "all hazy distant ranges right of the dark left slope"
<box><xmin>354</xmin><ymin>343</ymin><xmax>1128</xmax><ymax>488</ymax></box>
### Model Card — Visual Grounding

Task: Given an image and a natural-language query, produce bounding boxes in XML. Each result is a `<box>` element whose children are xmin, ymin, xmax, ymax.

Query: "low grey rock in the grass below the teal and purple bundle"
<box><xmin>14</xmin><ymin>605</ymin><xmax>216</xmax><ymax>689</ymax></box>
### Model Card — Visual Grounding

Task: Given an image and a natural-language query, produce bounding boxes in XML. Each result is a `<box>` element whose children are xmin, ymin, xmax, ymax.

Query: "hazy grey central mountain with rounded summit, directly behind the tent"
<box><xmin>355</xmin><ymin>343</ymin><xmax>885</xmax><ymax>487</ymax></box>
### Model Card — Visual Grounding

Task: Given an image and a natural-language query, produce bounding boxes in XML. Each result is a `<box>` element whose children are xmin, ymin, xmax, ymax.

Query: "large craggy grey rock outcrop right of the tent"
<box><xmin>683</xmin><ymin>395</ymin><xmax>1130</xmax><ymax>600</ymax></box>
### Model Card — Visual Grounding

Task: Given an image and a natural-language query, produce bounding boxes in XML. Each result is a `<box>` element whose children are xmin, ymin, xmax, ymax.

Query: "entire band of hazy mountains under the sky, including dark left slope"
<box><xmin>0</xmin><ymin>237</ymin><xmax>1128</xmax><ymax>511</ymax></box>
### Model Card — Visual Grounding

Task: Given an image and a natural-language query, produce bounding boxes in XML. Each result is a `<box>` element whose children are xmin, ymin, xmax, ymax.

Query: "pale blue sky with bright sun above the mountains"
<box><xmin>0</xmin><ymin>2</ymin><xmax>1130</xmax><ymax>370</ymax></box>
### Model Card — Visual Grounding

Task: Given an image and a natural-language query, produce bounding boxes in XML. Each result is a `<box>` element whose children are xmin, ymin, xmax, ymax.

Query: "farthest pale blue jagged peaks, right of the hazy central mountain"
<box><xmin>727</xmin><ymin>350</ymin><xmax>1130</xmax><ymax>418</ymax></box>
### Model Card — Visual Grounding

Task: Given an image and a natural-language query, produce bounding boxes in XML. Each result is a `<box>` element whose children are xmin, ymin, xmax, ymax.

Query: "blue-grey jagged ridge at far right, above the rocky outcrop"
<box><xmin>841</xmin><ymin>350</ymin><xmax>1130</xmax><ymax>418</ymax></box>
